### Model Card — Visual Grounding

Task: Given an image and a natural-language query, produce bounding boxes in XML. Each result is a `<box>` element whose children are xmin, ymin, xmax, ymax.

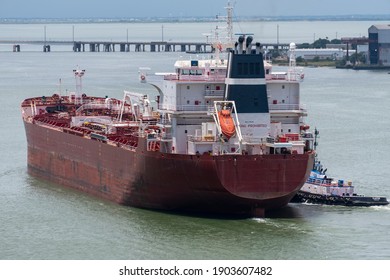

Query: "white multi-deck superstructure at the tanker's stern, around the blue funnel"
<box><xmin>140</xmin><ymin>40</ymin><xmax>311</xmax><ymax>154</ymax></box>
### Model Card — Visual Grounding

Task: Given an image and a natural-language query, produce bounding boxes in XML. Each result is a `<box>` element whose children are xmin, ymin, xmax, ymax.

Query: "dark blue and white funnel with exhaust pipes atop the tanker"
<box><xmin>224</xmin><ymin>36</ymin><xmax>271</xmax><ymax>143</ymax></box>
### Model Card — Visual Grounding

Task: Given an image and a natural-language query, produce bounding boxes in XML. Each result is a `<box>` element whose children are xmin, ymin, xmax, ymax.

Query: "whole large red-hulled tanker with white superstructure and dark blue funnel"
<box><xmin>21</xmin><ymin>37</ymin><xmax>314</xmax><ymax>217</ymax></box>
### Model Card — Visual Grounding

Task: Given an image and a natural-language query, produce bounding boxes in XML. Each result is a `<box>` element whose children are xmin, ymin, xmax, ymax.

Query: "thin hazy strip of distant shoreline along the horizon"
<box><xmin>0</xmin><ymin>15</ymin><xmax>390</xmax><ymax>24</ymax></box>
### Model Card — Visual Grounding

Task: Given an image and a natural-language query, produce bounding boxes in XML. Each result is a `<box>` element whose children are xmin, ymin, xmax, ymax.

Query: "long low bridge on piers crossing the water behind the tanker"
<box><xmin>0</xmin><ymin>40</ymin><xmax>289</xmax><ymax>53</ymax></box>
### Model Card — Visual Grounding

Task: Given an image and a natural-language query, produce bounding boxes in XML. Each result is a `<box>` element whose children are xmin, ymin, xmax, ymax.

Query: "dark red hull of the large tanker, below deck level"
<box><xmin>24</xmin><ymin>121</ymin><xmax>314</xmax><ymax>216</ymax></box>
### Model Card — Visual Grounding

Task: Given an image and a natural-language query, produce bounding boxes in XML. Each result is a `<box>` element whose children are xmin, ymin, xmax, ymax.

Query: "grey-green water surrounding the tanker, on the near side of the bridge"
<box><xmin>0</xmin><ymin>21</ymin><xmax>390</xmax><ymax>260</ymax></box>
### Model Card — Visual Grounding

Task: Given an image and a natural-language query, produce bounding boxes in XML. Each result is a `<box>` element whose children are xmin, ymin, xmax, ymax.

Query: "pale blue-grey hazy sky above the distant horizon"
<box><xmin>0</xmin><ymin>0</ymin><xmax>390</xmax><ymax>18</ymax></box>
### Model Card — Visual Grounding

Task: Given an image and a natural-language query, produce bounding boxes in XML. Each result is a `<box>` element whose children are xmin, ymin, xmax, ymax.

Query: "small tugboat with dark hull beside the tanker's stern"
<box><xmin>291</xmin><ymin>130</ymin><xmax>389</xmax><ymax>206</ymax></box>
